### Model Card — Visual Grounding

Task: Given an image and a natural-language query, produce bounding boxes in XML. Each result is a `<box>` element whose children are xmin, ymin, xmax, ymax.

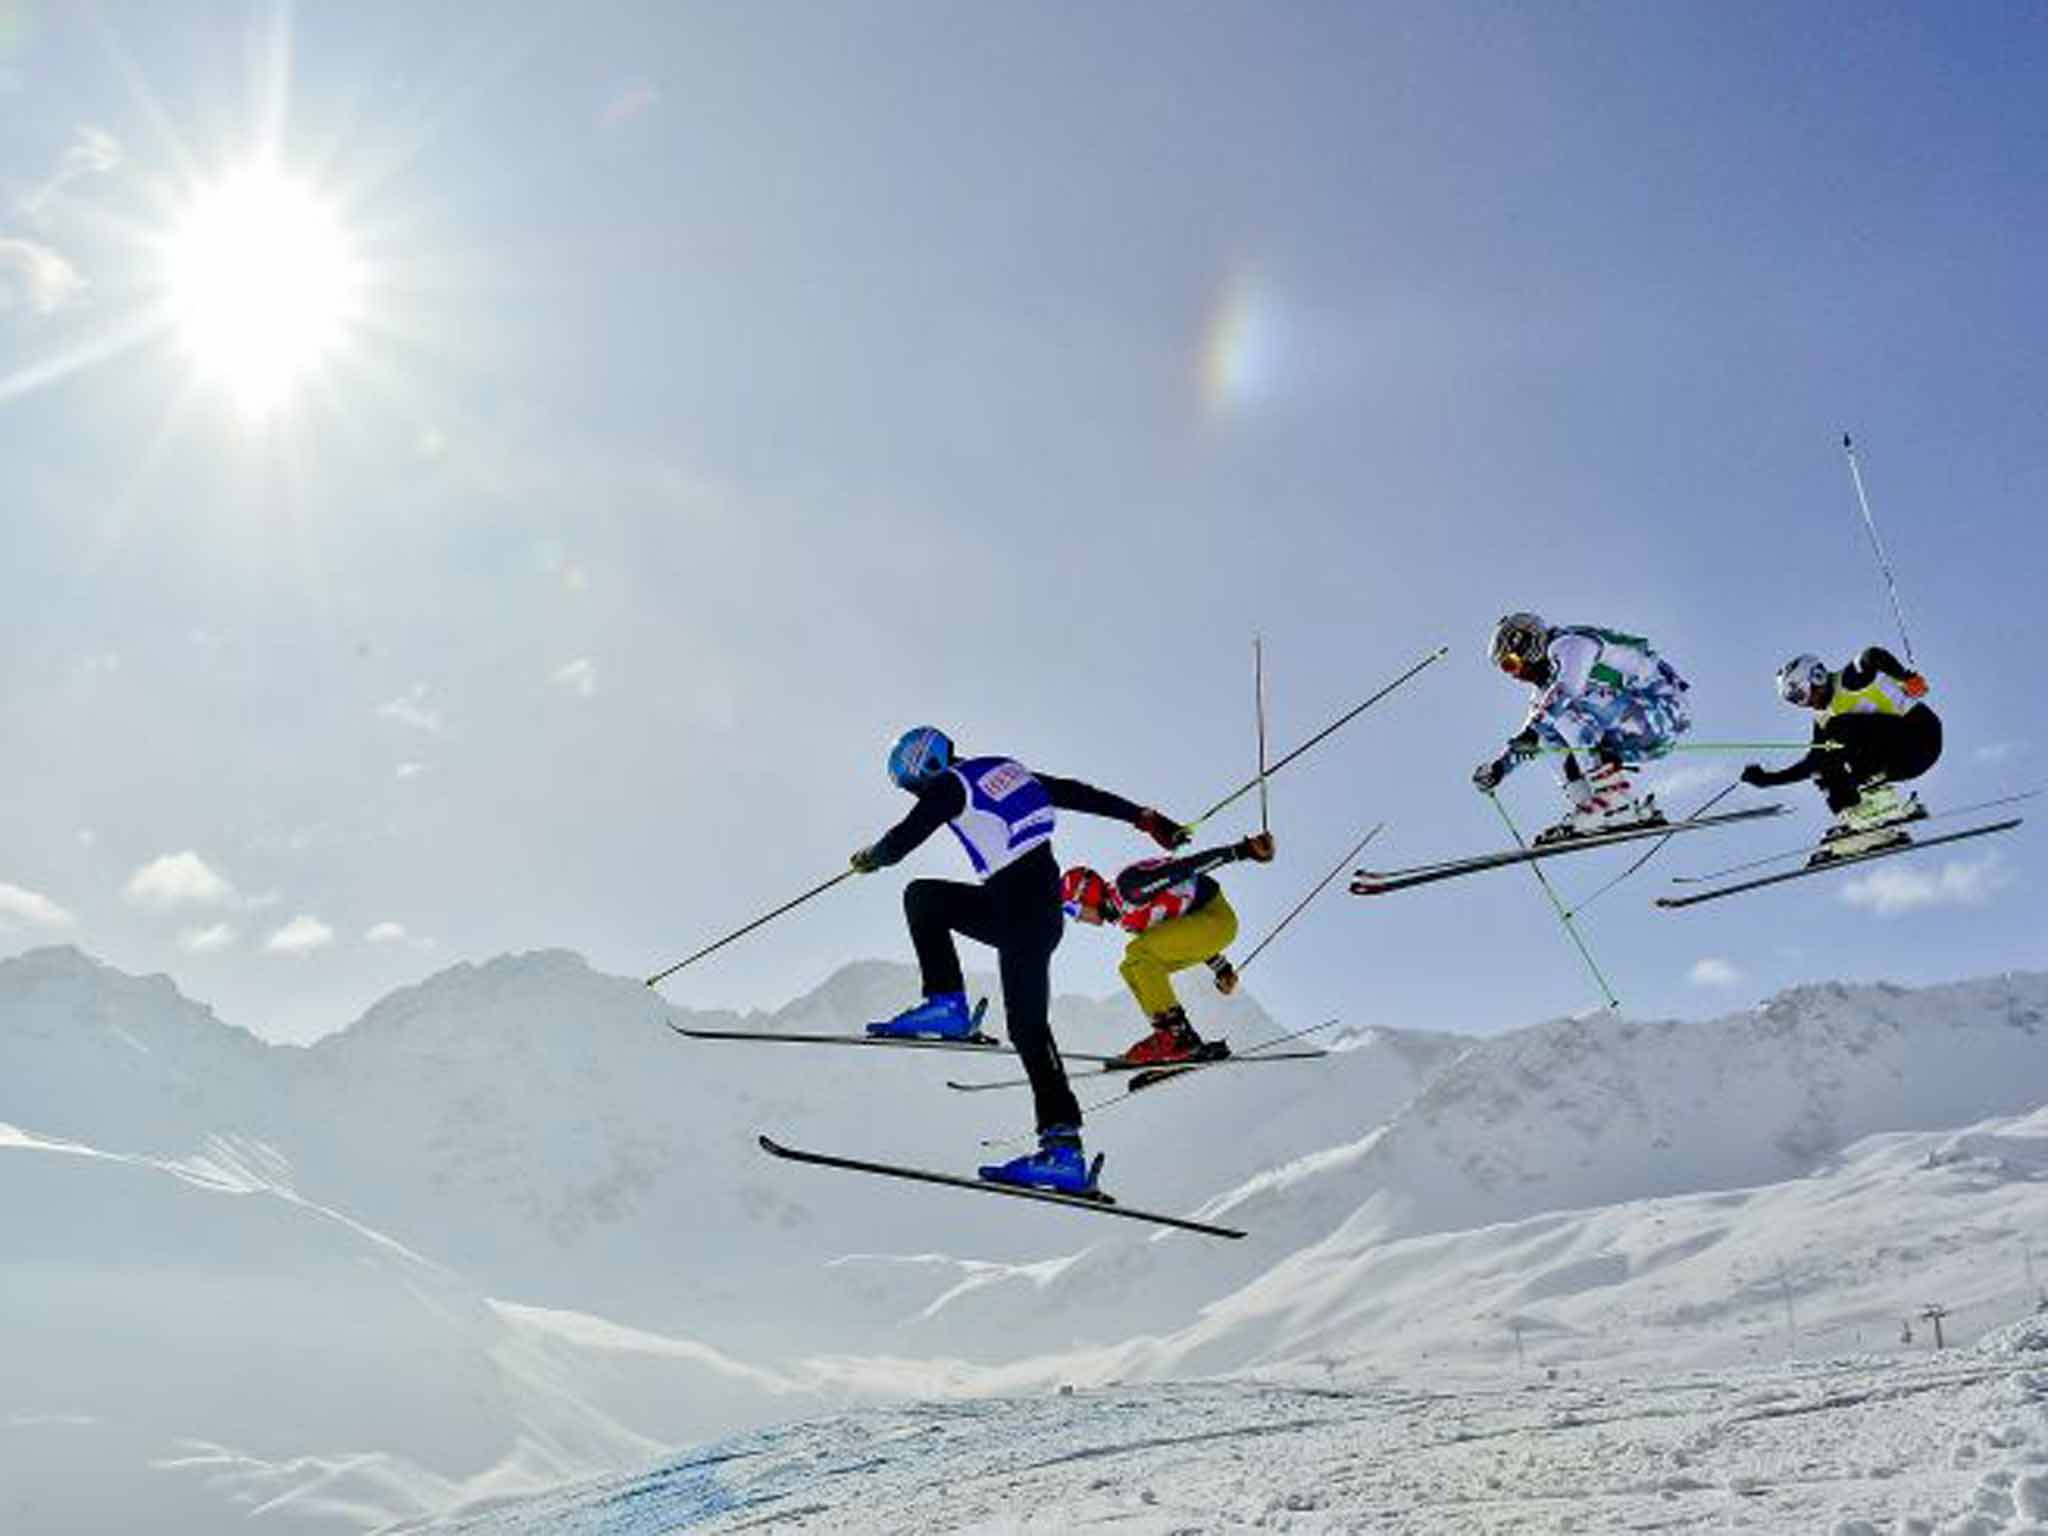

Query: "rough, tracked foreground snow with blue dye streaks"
<box><xmin>403</xmin><ymin>1319</ymin><xmax>2048</xmax><ymax>1536</ymax></box>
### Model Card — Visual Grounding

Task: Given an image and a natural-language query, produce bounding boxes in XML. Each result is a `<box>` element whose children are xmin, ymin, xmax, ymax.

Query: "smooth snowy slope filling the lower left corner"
<box><xmin>0</xmin><ymin>1126</ymin><xmax>827</xmax><ymax>1536</ymax></box>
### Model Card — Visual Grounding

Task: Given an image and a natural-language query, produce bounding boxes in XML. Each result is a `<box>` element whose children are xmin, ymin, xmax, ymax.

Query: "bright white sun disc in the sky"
<box><xmin>164</xmin><ymin>164</ymin><xmax>362</xmax><ymax>420</ymax></box>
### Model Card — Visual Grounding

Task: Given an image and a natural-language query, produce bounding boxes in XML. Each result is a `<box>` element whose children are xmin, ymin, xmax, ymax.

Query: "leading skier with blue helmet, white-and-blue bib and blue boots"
<box><xmin>852</xmin><ymin>725</ymin><xmax>1188</xmax><ymax>1194</ymax></box>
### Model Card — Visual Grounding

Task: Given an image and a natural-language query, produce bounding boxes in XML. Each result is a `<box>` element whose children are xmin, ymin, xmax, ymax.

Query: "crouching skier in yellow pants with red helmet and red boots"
<box><xmin>1059</xmin><ymin>831</ymin><xmax>1274</xmax><ymax>1067</ymax></box>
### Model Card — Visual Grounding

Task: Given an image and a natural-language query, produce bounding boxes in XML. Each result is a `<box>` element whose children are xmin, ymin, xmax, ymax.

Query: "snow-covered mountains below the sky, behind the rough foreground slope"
<box><xmin>0</xmin><ymin>950</ymin><xmax>2048</xmax><ymax>1532</ymax></box>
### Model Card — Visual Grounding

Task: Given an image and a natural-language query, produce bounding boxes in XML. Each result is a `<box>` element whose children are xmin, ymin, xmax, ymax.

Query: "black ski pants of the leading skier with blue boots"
<box><xmin>903</xmin><ymin>844</ymin><xmax>1081</xmax><ymax>1130</ymax></box>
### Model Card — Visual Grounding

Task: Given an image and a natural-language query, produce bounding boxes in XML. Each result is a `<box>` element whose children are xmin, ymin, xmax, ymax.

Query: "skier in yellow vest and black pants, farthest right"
<box><xmin>1743</xmin><ymin>645</ymin><xmax>1942</xmax><ymax>858</ymax></box>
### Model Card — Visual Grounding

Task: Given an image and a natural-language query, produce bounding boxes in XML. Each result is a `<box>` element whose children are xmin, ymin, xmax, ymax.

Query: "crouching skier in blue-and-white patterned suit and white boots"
<box><xmin>1473</xmin><ymin>612</ymin><xmax>1692</xmax><ymax>844</ymax></box>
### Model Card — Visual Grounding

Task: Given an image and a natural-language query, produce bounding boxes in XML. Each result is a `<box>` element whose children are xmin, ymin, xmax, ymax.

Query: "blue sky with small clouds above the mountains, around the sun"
<box><xmin>0</xmin><ymin>0</ymin><xmax>2048</xmax><ymax>1038</ymax></box>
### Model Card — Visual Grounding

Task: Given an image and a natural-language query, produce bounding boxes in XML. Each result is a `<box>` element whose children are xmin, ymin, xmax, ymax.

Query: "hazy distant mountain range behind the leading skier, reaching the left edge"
<box><xmin>0</xmin><ymin>950</ymin><xmax>1462</xmax><ymax>1358</ymax></box>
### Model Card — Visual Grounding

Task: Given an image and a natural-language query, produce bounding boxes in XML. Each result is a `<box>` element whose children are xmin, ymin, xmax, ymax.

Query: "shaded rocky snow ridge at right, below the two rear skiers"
<box><xmin>876</xmin><ymin>975</ymin><xmax>2048</xmax><ymax>1360</ymax></box>
